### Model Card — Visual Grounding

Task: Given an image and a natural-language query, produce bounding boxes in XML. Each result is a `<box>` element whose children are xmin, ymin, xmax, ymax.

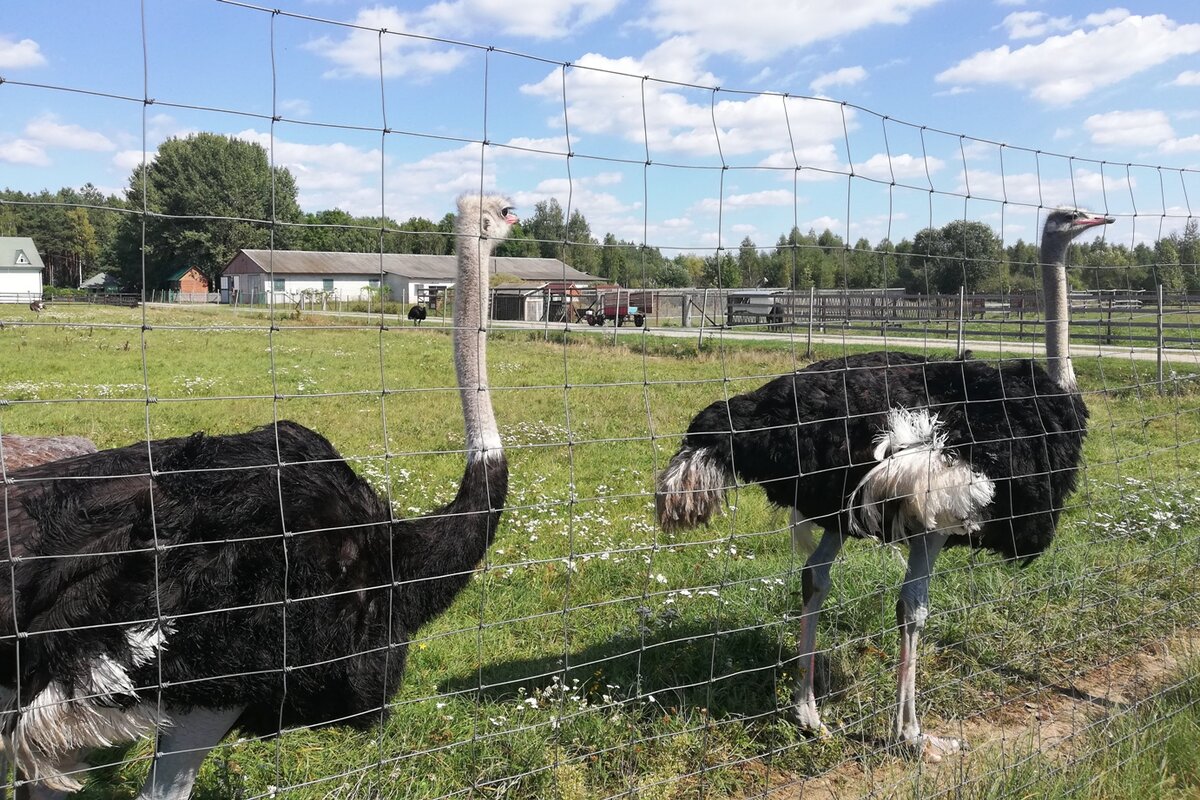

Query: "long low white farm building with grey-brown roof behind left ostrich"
<box><xmin>221</xmin><ymin>249</ymin><xmax>600</xmax><ymax>303</ymax></box>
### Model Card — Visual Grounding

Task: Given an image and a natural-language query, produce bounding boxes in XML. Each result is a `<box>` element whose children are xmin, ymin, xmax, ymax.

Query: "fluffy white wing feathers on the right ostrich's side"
<box><xmin>850</xmin><ymin>408</ymin><xmax>996</xmax><ymax>541</ymax></box>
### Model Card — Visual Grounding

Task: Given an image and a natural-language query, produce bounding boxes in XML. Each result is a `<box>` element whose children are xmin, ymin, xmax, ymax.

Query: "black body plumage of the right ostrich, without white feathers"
<box><xmin>683</xmin><ymin>353</ymin><xmax>1087</xmax><ymax>559</ymax></box>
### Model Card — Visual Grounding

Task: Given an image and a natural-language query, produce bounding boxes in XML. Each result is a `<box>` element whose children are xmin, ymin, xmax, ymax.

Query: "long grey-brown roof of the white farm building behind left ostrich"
<box><xmin>224</xmin><ymin>249</ymin><xmax>600</xmax><ymax>283</ymax></box>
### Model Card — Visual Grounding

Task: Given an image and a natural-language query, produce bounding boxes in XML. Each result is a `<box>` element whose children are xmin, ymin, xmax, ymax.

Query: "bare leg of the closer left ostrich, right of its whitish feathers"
<box><xmin>138</xmin><ymin>708</ymin><xmax>245</xmax><ymax>800</ymax></box>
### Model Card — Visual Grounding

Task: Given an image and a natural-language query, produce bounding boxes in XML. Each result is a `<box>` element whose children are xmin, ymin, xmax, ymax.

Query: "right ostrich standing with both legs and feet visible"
<box><xmin>656</xmin><ymin>209</ymin><xmax>1112</xmax><ymax>762</ymax></box>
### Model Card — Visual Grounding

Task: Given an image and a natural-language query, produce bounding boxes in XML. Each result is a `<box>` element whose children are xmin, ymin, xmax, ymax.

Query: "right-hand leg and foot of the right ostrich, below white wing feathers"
<box><xmin>895</xmin><ymin>531</ymin><xmax>964</xmax><ymax>763</ymax></box>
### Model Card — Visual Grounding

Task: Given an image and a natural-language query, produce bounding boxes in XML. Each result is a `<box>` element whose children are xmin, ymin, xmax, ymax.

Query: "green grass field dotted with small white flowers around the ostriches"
<box><xmin>0</xmin><ymin>306</ymin><xmax>1200</xmax><ymax>800</ymax></box>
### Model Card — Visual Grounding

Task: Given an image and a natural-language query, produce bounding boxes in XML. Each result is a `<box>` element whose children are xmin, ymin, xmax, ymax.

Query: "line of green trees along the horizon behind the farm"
<box><xmin>0</xmin><ymin>133</ymin><xmax>1200</xmax><ymax>293</ymax></box>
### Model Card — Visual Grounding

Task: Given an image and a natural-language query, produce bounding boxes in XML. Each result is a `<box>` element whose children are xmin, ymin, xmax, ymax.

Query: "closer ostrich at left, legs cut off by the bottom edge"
<box><xmin>0</xmin><ymin>196</ymin><xmax>516</xmax><ymax>800</ymax></box>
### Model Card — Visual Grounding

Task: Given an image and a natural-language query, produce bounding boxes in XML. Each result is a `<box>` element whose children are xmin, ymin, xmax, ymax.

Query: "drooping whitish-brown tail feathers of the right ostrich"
<box><xmin>654</xmin><ymin>445</ymin><xmax>733</xmax><ymax>531</ymax></box>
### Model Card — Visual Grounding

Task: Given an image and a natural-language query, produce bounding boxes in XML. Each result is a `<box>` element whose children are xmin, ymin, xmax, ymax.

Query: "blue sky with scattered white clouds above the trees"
<box><xmin>0</xmin><ymin>0</ymin><xmax>1200</xmax><ymax>255</ymax></box>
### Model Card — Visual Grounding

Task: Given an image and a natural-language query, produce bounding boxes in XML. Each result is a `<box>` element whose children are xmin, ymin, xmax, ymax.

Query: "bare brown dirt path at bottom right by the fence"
<box><xmin>744</xmin><ymin>630</ymin><xmax>1200</xmax><ymax>800</ymax></box>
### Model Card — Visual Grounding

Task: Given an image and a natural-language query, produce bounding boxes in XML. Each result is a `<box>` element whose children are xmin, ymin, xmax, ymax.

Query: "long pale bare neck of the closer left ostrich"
<box><xmin>454</xmin><ymin>225</ymin><xmax>502</xmax><ymax>463</ymax></box>
